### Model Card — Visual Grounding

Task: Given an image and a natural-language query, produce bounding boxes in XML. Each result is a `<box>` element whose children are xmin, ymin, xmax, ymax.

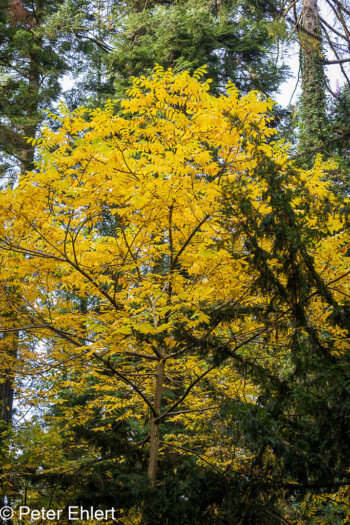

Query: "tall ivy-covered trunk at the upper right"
<box><xmin>299</xmin><ymin>0</ymin><xmax>327</xmax><ymax>167</ymax></box>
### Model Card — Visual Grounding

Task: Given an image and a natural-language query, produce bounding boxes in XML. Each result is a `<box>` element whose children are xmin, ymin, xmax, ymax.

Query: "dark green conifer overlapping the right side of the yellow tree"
<box><xmin>219</xmin><ymin>156</ymin><xmax>350</xmax><ymax>512</ymax></box>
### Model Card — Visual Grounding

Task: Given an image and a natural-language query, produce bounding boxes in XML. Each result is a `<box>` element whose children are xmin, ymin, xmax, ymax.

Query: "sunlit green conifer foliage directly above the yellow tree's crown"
<box><xmin>110</xmin><ymin>0</ymin><xmax>284</xmax><ymax>94</ymax></box>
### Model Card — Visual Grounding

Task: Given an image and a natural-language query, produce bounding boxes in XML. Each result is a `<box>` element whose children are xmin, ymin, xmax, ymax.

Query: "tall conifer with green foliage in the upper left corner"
<box><xmin>0</xmin><ymin>0</ymin><xmax>66</xmax><ymax>177</ymax></box>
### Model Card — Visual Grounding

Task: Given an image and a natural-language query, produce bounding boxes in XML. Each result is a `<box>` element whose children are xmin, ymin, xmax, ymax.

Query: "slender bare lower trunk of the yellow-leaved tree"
<box><xmin>148</xmin><ymin>360</ymin><xmax>165</xmax><ymax>487</ymax></box>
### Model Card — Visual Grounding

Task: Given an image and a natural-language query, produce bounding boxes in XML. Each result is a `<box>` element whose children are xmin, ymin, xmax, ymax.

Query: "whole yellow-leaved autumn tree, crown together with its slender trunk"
<box><xmin>0</xmin><ymin>68</ymin><xmax>349</xmax><ymax>523</ymax></box>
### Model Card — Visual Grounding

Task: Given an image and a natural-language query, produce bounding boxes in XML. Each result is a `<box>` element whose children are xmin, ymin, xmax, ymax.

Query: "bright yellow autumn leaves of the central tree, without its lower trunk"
<box><xmin>0</xmin><ymin>68</ymin><xmax>348</xmax><ymax>488</ymax></box>
